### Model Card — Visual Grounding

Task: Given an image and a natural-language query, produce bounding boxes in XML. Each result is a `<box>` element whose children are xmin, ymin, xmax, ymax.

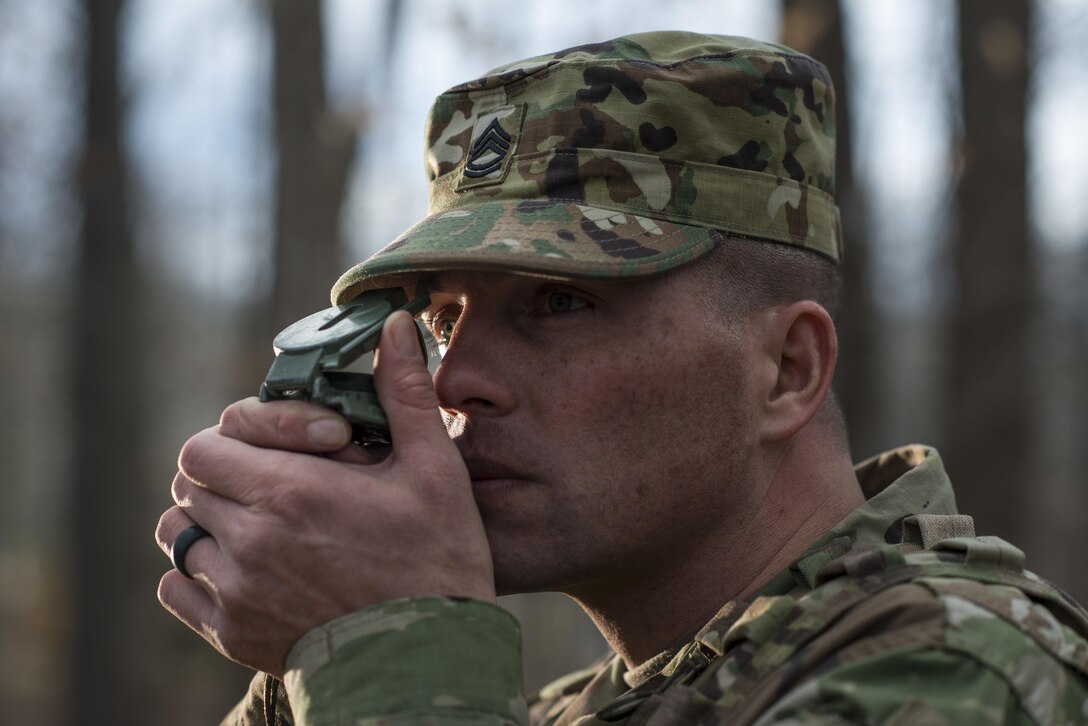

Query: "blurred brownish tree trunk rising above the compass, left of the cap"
<box><xmin>265</xmin><ymin>0</ymin><xmax>356</xmax><ymax>343</ymax></box>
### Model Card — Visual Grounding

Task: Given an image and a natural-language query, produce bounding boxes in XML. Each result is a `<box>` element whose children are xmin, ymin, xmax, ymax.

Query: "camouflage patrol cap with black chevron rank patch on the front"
<box><xmin>332</xmin><ymin>32</ymin><xmax>842</xmax><ymax>304</ymax></box>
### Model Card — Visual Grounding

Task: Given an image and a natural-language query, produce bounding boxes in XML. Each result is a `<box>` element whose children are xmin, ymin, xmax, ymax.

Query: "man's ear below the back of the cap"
<box><xmin>759</xmin><ymin>300</ymin><xmax>839</xmax><ymax>441</ymax></box>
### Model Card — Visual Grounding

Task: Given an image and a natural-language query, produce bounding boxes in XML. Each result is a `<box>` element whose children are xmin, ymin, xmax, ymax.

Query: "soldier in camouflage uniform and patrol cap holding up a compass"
<box><xmin>157</xmin><ymin>33</ymin><xmax>1088</xmax><ymax>724</ymax></box>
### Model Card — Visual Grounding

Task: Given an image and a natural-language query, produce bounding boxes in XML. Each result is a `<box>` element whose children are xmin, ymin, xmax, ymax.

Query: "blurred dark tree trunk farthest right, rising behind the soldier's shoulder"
<box><xmin>945</xmin><ymin>0</ymin><xmax>1037</xmax><ymax>541</ymax></box>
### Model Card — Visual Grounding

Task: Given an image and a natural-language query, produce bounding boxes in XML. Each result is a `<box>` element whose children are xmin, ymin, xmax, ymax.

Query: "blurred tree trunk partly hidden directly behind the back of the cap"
<box><xmin>781</xmin><ymin>0</ymin><xmax>882</xmax><ymax>458</ymax></box>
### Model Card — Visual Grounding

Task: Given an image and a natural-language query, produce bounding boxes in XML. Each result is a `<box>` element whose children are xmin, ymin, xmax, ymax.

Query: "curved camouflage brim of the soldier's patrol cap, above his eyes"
<box><xmin>332</xmin><ymin>199</ymin><xmax>719</xmax><ymax>305</ymax></box>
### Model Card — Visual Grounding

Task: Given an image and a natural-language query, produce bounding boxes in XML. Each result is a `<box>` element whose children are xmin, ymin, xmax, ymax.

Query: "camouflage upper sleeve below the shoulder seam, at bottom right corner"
<box><xmin>752</xmin><ymin>576</ymin><xmax>1088</xmax><ymax>724</ymax></box>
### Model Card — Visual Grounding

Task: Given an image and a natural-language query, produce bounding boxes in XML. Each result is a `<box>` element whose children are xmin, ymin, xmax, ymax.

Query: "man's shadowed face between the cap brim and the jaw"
<box><xmin>422</xmin><ymin>264</ymin><xmax>757</xmax><ymax>596</ymax></box>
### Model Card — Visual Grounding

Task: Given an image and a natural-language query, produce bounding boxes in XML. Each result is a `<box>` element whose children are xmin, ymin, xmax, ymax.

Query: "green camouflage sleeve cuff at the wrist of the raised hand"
<box><xmin>276</xmin><ymin>598</ymin><xmax>528</xmax><ymax>726</ymax></box>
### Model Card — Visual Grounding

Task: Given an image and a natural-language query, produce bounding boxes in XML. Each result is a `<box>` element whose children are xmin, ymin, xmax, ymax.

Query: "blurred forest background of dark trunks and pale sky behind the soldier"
<box><xmin>0</xmin><ymin>0</ymin><xmax>1088</xmax><ymax>726</ymax></box>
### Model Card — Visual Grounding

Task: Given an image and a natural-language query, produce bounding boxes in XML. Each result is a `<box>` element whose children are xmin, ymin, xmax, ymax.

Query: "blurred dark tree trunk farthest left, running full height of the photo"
<box><xmin>65</xmin><ymin>0</ymin><xmax>146</xmax><ymax>726</ymax></box>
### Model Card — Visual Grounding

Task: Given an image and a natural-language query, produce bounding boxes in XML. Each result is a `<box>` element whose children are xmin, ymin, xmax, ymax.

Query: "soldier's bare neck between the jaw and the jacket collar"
<box><xmin>567</xmin><ymin>437</ymin><xmax>864</xmax><ymax>667</ymax></box>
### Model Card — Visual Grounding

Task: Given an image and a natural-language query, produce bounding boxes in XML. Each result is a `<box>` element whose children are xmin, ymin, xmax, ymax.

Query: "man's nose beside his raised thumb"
<box><xmin>434</xmin><ymin>309</ymin><xmax>517</xmax><ymax>419</ymax></box>
